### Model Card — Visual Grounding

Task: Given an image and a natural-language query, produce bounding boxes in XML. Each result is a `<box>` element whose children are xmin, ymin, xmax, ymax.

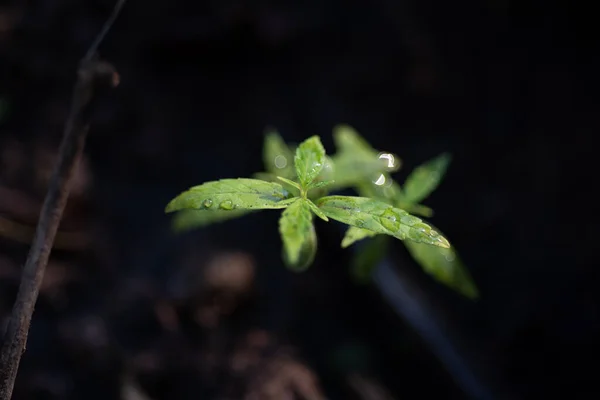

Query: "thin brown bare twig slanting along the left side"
<box><xmin>0</xmin><ymin>0</ymin><xmax>125</xmax><ymax>400</ymax></box>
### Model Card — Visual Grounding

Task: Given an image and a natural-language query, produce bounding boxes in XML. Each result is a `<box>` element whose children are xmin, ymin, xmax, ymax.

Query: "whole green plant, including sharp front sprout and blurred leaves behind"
<box><xmin>165</xmin><ymin>125</ymin><xmax>478</xmax><ymax>298</ymax></box>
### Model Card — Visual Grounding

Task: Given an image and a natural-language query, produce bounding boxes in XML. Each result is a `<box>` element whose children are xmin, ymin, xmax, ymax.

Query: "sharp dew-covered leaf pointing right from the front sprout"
<box><xmin>317</xmin><ymin>196</ymin><xmax>450</xmax><ymax>247</ymax></box>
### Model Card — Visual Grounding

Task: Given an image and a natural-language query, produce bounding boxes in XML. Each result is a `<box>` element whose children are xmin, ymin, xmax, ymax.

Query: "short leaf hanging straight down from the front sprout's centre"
<box><xmin>279</xmin><ymin>199</ymin><xmax>317</xmax><ymax>271</ymax></box>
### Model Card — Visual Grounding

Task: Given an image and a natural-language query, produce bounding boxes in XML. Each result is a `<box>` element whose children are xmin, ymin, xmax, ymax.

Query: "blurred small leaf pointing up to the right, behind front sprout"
<box><xmin>402</xmin><ymin>153</ymin><xmax>451</xmax><ymax>204</ymax></box>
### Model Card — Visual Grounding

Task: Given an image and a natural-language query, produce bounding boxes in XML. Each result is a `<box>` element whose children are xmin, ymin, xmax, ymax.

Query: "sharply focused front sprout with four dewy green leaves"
<box><xmin>165</xmin><ymin>136</ymin><xmax>450</xmax><ymax>270</ymax></box>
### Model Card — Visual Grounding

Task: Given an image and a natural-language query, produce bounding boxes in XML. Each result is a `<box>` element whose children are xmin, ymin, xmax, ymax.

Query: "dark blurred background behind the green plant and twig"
<box><xmin>0</xmin><ymin>0</ymin><xmax>600</xmax><ymax>400</ymax></box>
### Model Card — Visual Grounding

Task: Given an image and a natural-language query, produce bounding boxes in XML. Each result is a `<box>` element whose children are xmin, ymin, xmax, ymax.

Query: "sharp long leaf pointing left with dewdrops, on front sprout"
<box><xmin>165</xmin><ymin>178</ymin><xmax>289</xmax><ymax>213</ymax></box>
